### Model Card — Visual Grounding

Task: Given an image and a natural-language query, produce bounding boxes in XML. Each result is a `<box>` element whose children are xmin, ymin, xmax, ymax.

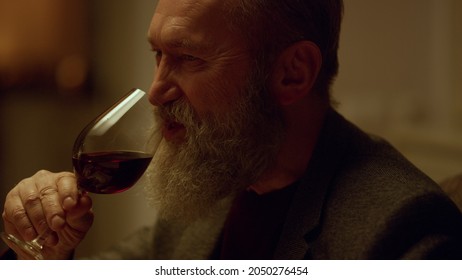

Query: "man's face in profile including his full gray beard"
<box><xmin>148</xmin><ymin>0</ymin><xmax>283</xmax><ymax>218</ymax></box>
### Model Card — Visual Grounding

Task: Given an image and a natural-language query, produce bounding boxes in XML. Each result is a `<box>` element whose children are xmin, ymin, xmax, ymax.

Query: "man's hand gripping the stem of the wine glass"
<box><xmin>2</xmin><ymin>171</ymin><xmax>93</xmax><ymax>259</ymax></box>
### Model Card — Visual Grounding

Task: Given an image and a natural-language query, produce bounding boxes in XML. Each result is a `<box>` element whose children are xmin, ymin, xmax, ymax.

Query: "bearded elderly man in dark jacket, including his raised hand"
<box><xmin>3</xmin><ymin>0</ymin><xmax>462</xmax><ymax>259</ymax></box>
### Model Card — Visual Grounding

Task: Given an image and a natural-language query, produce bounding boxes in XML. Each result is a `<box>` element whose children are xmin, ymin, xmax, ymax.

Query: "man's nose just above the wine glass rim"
<box><xmin>149</xmin><ymin>62</ymin><xmax>182</xmax><ymax>106</ymax></box>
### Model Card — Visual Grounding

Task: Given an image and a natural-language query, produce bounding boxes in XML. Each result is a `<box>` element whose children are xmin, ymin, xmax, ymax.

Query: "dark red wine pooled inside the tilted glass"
<box><xmin>72</xmin><ymin>151</ymin><xmax>152</xmax><ymax>194</ymax></box>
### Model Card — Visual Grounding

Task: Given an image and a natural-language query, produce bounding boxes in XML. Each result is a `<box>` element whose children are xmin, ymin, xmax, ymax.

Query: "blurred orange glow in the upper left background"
<box><xmin>0</xmin><ymin>0</ymin><xmax>89</xmax><ymax>90</ymax></box>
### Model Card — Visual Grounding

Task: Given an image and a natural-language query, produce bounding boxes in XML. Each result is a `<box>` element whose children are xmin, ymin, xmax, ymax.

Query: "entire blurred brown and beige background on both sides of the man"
<box><xmin>0</xmin><ymin>0</ymin><xmax>462</xmax><ymax>257</ymax></box>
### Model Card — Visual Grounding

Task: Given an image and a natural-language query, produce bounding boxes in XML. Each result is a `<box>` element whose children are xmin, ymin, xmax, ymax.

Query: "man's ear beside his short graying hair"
<box><xmin>271</xmin><ymin>41</ymin><xmax>322</xmax><ymax>105</ymax></box>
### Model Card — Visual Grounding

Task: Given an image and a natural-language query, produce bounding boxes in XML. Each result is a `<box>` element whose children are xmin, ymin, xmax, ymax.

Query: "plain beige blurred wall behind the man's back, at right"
<box><xmin>335</xmin><ymin>0</ymin><xmax>462</xmax><ymax>181</ymax></box>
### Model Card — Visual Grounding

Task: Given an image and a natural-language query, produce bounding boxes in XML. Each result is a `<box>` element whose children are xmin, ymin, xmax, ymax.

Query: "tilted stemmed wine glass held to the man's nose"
<box><xmin>1</xmin><ymin>89</ymin><xmax>162</xmax><ymax>260</ymax></box>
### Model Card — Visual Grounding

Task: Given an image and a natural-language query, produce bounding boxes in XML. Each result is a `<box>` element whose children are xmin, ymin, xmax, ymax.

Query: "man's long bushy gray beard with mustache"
<box><xmin>146</xmin><ymin>74</ymin><xmax>284</xmax><ymax>221</ymax></box>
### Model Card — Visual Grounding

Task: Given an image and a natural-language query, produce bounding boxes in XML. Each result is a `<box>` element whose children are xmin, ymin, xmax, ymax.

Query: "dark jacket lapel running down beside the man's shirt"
<box><xmin>274</xmin><ymin>109</ymin><xmax>351</xmax><ymax>259</ymax></box>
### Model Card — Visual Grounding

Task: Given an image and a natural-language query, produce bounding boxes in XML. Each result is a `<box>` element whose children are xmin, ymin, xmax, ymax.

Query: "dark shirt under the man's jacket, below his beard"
<box><xmin>212</xmin><ymin>184</ymin><xmax>296</xmax><ymax>260</ymax></box>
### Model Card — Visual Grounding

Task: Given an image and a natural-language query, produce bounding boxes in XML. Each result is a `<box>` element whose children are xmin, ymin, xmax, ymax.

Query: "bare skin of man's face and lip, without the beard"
<box><xmin>149</xmin><ymin>0</ymin><xmax>250</xmax><ymax>138</ymax></box>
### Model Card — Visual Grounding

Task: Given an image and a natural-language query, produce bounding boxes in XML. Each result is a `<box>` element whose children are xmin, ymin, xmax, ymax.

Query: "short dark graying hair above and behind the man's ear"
<box><xmin>226</xmin><ymin>0</ymin><xmax>343</xmax><ymax>98</ymax></box>
